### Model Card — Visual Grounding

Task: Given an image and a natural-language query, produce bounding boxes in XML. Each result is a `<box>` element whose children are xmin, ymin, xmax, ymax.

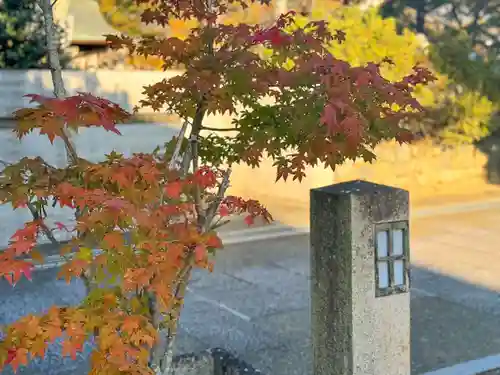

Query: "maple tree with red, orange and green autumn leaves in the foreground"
<box><xmin>0</xmin><ymin>0</ymin><xmax>433</xmax><ymax>375</ymax></box>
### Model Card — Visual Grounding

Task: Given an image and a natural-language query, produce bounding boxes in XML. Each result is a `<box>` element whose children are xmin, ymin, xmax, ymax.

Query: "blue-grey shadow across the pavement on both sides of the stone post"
<box><xmin>0</xmin><ymin>235</ymin><xmax>500</xmax><ymax>375</ymax></box>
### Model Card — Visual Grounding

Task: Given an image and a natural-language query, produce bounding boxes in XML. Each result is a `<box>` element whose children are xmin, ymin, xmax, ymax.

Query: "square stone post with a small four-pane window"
<box><xmin>311</xmin><ymin>181</ymin><xmax>411</xmax><ymax>375</ymax></box>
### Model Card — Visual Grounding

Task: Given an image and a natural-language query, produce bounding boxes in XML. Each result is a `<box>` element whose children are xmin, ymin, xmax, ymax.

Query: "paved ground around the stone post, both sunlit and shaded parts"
<box><xmin>0</xmin><ymin>209</ymin><xmax>500</xmax><ymax>375</ymax></box>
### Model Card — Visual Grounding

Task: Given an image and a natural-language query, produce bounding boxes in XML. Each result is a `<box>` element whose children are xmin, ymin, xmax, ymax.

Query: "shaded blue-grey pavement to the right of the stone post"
<box><xmin>411</xmin><ymin>267</ymin><xmax>500</xmax><ymax>374</ymax></box>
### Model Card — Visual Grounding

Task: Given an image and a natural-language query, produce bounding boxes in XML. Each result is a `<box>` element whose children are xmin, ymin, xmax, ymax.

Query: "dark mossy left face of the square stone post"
<box><xmin>310</xmin><ymin>183</ymin><xmax>353</xmax><ymax>375</ymax></box>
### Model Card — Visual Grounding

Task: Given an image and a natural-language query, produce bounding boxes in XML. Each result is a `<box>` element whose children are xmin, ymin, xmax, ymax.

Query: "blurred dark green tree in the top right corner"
<box><xmin>380</xmin><ymin>0</ymin><xmax>500</xmax><ymax>102</ymax></box>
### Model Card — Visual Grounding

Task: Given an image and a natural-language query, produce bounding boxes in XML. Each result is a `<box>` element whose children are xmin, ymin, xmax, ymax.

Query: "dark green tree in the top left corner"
<box><xmin>0</xmin><ymin>0</ymin><xmax>68</xmax><ymax>69</ymax></box>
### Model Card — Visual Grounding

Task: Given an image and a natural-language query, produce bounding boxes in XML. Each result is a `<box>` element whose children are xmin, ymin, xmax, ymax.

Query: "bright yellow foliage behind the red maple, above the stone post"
<box><xmin>302</xmin><ymin>6</ymin><xmax>497</xmax><ymax>143</ymax></box>
